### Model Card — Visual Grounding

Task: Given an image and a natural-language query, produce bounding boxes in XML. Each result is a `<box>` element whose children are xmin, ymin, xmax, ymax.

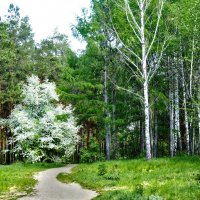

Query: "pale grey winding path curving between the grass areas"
<box><xmin>21</xmin><ymin>165</ymin><xmax>97</xmax><ymax>200</ymax></box>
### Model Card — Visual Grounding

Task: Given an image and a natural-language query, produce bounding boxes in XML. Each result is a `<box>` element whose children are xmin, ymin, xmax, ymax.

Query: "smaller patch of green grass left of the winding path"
<box><xmin>0</xmin><ymin>163</ymin><xmax>63</xmax><ymax>200</ymax></box>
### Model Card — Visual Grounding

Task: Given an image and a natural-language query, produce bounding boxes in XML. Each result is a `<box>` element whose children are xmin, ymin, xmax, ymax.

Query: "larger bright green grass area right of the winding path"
<box><xmin>57</xmin><ymin>157</ymin><xmax>200</xmax><ymax>200</ymax></box>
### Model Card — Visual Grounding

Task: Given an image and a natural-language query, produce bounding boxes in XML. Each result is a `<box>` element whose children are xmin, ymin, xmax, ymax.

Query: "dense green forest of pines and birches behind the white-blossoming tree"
<box><xmin>0</xmin><ymin>0</ymin><xmax>200</xmax><ymax>163</ymax></box>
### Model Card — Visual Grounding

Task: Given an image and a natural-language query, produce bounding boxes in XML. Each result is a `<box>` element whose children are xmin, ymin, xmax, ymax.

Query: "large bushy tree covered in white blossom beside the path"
<box><xmin>9</xmin><ymin>75</ymin><xmax>79</xmax><ymax>162</ymax></box>
